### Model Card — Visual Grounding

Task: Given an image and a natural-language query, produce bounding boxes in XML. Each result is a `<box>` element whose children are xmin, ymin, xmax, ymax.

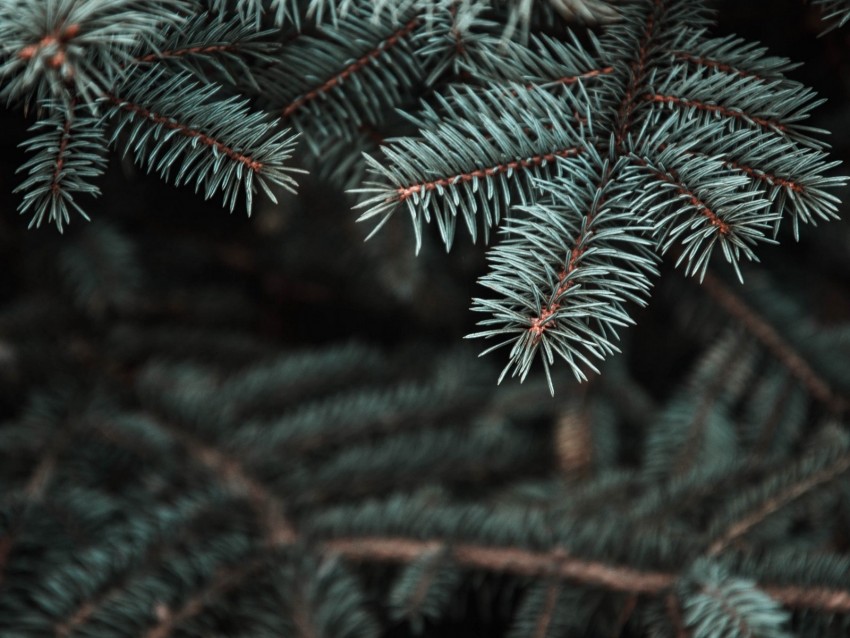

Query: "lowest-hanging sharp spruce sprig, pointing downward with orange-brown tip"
<box><xmin>464</xmin><ymin>149</ymin><xmax>655</xmax><ymax>392</ymax></box>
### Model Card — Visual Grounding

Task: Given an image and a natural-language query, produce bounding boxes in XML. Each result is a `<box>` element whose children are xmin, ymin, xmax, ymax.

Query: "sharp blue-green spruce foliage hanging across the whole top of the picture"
<box><xmin>0</xmin><ymin>0</ymin><xmax>844</xmax><ymax>378</ymax></box>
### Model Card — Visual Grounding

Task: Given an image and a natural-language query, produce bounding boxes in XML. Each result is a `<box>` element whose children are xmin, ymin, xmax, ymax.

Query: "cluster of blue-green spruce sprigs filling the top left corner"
<box><xmin>0</xmin><ymin>0</ymin><xmax>302</xmax><ymax>230</ymax></box>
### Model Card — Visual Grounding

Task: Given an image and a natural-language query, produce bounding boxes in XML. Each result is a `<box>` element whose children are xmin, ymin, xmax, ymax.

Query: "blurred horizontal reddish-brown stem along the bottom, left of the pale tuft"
<box><xmin>324</xmin><ymin>537</ymin><xmax>676</xmax><ymax>594</ymax></box>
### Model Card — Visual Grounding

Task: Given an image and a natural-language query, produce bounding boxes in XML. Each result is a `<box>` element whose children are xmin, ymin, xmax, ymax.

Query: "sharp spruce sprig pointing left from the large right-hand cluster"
<box><xmin>353</xmin><ymin>86</ymin><xmax>581</xmax><ymax>251</ymax></box>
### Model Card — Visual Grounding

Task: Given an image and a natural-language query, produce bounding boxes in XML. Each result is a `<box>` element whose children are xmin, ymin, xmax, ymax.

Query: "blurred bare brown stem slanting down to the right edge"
<box><xmin>702</xmin><ymin>273</ymin><xmax>847</xmax><ymax>413</ymax></box>
